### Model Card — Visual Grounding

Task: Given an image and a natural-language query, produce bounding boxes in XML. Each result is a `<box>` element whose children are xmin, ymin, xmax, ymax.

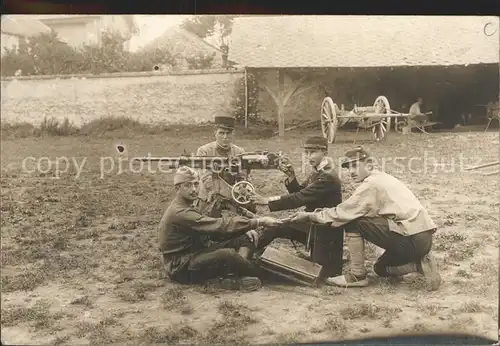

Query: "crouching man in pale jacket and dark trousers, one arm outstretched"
<box><xmin>282</xmin><ymin>147</ymin><xmax>441</xmax><ymax>290</ymax></box>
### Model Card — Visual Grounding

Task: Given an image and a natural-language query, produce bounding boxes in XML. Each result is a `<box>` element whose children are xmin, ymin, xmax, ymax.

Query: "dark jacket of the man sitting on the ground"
<box><xmin>158</xmin><ymin>197</ymin><xmax>257</xmax><ymax>275</ymax></box>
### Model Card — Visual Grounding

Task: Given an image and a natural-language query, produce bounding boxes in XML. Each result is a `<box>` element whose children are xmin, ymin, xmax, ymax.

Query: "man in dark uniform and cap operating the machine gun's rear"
<box><xmin>252</xmin><ymin>136</ymin><xmax>343</xmax><ymax>276</ymax></box>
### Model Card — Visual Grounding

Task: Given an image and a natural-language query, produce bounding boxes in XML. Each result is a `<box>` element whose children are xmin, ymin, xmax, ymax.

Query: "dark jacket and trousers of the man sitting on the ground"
<box><xmin>159</xmin><ymin>197</ymin><xmax>257</xmax><ymax>283</ymax></box>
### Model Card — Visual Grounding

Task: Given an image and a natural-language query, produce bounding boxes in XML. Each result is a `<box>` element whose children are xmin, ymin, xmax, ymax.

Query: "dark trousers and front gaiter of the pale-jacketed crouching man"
<box><xmin>344</xmin><ymin>217</ymin><xmax>435</xmax><ymax>276</ymax></box>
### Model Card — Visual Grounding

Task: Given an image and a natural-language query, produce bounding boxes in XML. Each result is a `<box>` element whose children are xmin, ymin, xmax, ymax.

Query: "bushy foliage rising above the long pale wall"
<box><xmin>1</xmin><ymin>31</ymin><xmax>176</xmax><ymax>76</ymax></box>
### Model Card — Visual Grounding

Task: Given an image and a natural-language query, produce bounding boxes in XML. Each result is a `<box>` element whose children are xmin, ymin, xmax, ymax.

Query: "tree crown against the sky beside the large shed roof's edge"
<box><xmin>181</xmin><ymin>15</ymin><xmax>236</xmax><ymax>49</ymax></box>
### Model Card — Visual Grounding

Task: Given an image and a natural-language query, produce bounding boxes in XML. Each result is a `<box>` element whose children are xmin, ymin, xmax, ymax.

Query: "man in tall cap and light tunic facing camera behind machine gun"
<box><xmin>196</xmin><ymin>116</ymin><xmax>246</xmax><ymax>216</ymax></box>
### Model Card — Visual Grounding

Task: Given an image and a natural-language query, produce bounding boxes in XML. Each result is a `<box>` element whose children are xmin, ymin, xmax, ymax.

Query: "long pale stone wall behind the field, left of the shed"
<box><xmin>1</xmin><ymin>70</ymin><xmax>244</xmax><ymax>126</ymax></box>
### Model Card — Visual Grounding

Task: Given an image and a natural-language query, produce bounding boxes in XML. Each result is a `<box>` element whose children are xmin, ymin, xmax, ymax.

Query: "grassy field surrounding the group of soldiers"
<box><xmin>1</xmin><ymin>125</ymin><xmax>500</xmax><ymax>344</ymax></box>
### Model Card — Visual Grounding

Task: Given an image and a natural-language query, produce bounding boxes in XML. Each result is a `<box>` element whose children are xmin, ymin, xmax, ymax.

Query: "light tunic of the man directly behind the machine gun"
<box><xmin>196</xmin><ymin>141</ymin><xmax>245</xmax><ymax>216</ymax></box>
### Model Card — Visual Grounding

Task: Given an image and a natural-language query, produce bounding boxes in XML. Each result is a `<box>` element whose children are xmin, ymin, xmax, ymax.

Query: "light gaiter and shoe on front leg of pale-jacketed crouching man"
<box><xmin>325</xmin><ymin>233</ymin><xmax>370</xmax><ymax>287</ymax></box>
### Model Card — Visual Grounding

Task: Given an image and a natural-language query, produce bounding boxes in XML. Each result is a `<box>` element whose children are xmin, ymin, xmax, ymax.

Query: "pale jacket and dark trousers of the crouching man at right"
<box><xmin>310</xmin><ymin>170</ymin><xmax>437</xmax><ymax>276</ymax></box>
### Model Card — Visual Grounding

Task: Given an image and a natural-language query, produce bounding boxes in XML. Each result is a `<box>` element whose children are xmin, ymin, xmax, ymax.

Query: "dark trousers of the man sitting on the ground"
<box><xmin>174</xmin><ymin>235</ymin><xmax>256</xmax><ymax>284</ymax></box>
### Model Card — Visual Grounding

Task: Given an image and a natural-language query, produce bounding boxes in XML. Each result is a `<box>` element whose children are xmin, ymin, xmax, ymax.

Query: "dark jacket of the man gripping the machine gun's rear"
<box><xmin>269</xmin><ymin>160</ymin><xmax>342</xmax><ymax>212</ymax></box>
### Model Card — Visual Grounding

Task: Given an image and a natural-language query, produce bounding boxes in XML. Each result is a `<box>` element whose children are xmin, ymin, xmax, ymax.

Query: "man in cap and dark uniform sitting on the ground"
<box><xmin>159</xmin><ymin>167</ymin><xmax>279</xmax><ymax>290</ymax></box>
